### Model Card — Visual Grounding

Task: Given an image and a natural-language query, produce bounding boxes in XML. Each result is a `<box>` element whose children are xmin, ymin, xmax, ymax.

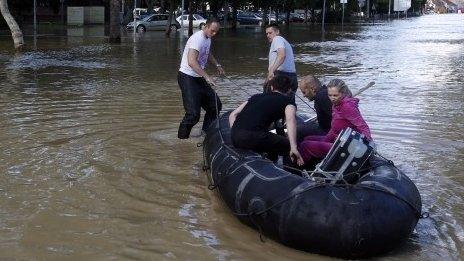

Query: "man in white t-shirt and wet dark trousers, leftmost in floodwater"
<box><xmin>177</xmin><ymin>19</ymin><xmax>224</xmax><ymax>139</ymax></box>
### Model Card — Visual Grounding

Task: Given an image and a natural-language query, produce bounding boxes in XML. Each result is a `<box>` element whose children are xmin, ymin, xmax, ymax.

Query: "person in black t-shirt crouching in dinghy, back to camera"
<box><xmin>229</xmin><ymin>75</ymin><xmax>303</xmax><ymax>165</ymax></box>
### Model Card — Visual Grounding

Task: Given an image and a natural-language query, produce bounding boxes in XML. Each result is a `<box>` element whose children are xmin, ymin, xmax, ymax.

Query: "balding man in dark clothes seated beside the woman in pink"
<box><xmin>297</xmin><ymin>75</ymin><xmax>332</xmax><ymax>140</ymax></box>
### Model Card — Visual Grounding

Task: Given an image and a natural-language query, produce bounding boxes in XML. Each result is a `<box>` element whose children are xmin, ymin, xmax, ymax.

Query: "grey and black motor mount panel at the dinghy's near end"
<box><xmin>316</xmin><ymin>128</ymin><xmax>375</xmax><ymax>183</ymax></box>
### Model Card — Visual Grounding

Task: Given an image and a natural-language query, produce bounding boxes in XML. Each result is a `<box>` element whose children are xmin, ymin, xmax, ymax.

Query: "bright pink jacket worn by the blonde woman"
<box><xmin>325</xmin><ymin>97</ymin><xmax>372</xmax><ymax>142</ymax></box>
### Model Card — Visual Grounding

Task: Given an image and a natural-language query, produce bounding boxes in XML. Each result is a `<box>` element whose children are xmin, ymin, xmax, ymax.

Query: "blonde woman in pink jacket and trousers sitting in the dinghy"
<box><xmin>298</xmin><ymin>79</ymin><xmax>372</xmax><ymax>163</ymax></box>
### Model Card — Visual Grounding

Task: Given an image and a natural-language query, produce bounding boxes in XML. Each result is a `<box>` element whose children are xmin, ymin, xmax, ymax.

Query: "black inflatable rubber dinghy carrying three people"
<box><xmin>203</xmin><ymin>113</ymin><xmax>422</xmax><ymax>258</ymax></box>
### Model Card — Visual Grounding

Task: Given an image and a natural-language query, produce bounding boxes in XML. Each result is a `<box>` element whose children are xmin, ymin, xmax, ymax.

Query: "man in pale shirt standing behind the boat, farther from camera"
<box><xmin>264</xmin><ymin>24</ymin><xmax>298</xmax><ymax>97</ymax></box>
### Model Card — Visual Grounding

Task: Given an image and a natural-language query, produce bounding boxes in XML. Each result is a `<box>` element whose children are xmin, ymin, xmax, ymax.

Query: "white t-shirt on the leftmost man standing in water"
<box><xmin>179</xmin><ymin>30</ymin><xmax>211</xmax><ymax>77</ymax></box>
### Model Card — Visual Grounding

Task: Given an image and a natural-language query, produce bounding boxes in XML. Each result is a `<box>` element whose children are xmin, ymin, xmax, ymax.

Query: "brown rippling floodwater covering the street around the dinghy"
<box><xmin>0</xmin><ymin>14</ymin><xmax>464</xmax><ymax>260</ymax></box>
